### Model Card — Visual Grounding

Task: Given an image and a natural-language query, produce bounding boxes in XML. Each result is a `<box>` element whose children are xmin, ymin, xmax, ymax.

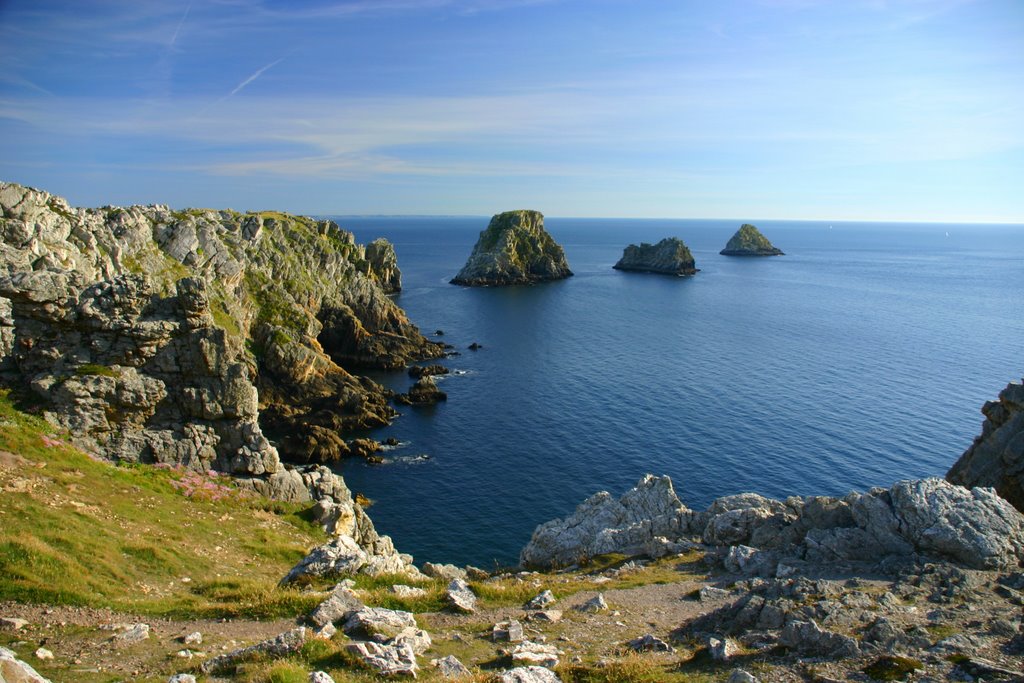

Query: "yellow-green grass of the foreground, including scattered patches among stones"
<box><xmin>0</xmin><ymin>391</ymin><xmax>724</xmax><ymax>683</ymax></box>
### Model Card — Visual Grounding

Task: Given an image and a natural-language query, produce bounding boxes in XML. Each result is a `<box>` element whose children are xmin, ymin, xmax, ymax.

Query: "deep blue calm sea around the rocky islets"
<box><xmin>327</xmin><ymin>217</ymin><xmax>1024</xmax><ymax>567</ymax></box>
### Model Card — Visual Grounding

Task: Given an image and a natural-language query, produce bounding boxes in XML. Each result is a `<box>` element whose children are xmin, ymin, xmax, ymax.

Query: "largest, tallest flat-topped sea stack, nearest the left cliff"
<box><xmin>452</xmin><ymin>210</ymin><xmax>572</xmax><ymax>287</ymax></box>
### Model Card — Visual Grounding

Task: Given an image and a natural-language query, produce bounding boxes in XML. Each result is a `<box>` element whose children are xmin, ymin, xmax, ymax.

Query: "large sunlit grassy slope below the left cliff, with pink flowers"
<box><xmin>0</xmin><ymin>391</ymin><xmax>324</xmax><ymax>618</ymax></box>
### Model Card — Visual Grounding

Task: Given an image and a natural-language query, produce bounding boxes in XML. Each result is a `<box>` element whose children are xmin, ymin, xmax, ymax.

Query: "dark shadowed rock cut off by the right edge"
<box><xmin>946</xmin><ymin>382</ymin><xmax>1024</xmax><ymax>512</ymax></box>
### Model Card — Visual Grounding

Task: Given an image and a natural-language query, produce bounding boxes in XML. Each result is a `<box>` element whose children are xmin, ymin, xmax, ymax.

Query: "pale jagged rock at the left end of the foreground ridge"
<box><xmin>519</xmin><ymin>474</ymin><xmax>693</xmax><ymax>567</ymax></box>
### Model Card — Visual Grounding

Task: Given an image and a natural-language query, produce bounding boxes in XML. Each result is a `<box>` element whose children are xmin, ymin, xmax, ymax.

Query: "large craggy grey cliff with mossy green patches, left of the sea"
<box><xmin>0</xmin><ymin>183</ymin><xmax>441</xmax><ymax>473</ymax></box>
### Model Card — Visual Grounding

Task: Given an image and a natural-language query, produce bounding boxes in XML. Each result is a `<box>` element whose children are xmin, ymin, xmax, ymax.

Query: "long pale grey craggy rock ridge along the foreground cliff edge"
<box><xmin>520</xmin><ymin>475</ymin><xmax>1024</xmax><ymax>575</ymax></box>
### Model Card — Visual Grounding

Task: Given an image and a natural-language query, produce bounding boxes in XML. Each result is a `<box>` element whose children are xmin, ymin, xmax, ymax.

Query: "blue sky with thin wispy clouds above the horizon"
<box><xmin>0</xmin><ymin>0</ymin><xmax>1024</xmax><ymax>222</ymax></box>
